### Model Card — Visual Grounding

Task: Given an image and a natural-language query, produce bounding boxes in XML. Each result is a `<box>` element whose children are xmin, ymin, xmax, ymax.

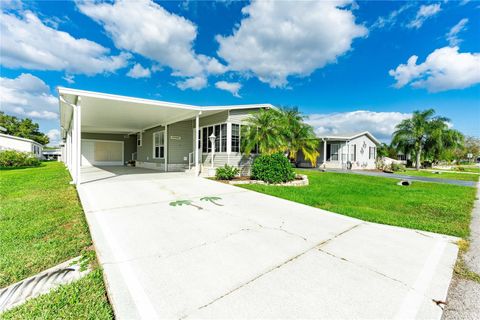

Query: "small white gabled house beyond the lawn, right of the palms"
<box><xmin>297</xmin><ymin>131</ymin><xmax>380</xmax><ymax>170</ymax></box>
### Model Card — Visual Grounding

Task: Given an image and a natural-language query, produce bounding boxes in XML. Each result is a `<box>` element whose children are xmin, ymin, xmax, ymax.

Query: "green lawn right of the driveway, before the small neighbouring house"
<box><xmin>242</xmin><ymin>170</ymin><xmax>475</xmax><ymax>237</ymax></box>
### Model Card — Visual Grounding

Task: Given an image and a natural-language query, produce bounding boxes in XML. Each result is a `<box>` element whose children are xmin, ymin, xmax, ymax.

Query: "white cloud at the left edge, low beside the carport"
<box><xmin>0</xmin><ymin>73</ymin><xmax>58</xmax><ymax>119</ymax></box>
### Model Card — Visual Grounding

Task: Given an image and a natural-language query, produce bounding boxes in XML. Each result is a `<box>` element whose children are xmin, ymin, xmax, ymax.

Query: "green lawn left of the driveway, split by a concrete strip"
<box><xmin>0</xmin><ymin>162</ymin><xmax>112</xmax><ymax>318</ymax></box>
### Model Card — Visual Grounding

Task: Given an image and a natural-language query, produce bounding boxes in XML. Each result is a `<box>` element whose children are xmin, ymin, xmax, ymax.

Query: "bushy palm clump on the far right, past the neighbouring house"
<box><xmin>392</xmin><ymin>109</ymin><xmax>463</xmax><ymax>170</ymax></box>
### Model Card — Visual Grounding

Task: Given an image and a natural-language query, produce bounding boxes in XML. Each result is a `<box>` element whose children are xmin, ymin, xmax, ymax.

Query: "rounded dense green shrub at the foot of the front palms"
<box><xmin>252</xmin><ymin>153</ymin><xmax>295</xmax><ymax>183</ymax></box>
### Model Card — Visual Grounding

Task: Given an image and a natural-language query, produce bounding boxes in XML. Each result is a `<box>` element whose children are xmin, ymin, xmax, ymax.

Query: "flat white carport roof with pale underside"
<box><xmin>57</xmin><ymin>87</ymin><xmax>274</xmax><ymax>134</ymax></box>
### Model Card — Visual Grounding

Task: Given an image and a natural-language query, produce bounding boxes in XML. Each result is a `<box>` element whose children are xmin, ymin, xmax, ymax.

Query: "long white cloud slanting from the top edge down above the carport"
<box><xmin>77</xmin><ymin>0</ymin><xmax>225</xmax><ymax>83</ymax></box>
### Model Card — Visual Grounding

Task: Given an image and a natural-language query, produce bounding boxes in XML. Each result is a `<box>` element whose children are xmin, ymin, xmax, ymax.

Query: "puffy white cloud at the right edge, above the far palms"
<box><xmin>389</xmin><ymin>47</ymin><xmax>480</xmax><ymax>92</ymax></box>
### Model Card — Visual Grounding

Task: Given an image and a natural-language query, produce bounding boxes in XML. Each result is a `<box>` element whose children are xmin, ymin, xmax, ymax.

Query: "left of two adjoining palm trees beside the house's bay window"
<box><xmin>241</xmin><ymin>109</ymin><xmax>285</xmax><ymax>155</ymax></box>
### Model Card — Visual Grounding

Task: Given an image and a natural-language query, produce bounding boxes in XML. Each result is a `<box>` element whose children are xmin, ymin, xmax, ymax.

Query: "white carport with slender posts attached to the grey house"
<box><xmin>57</xmin><ymin>87</ymin><xmax>258</xmax><ymax>184</ymax></box>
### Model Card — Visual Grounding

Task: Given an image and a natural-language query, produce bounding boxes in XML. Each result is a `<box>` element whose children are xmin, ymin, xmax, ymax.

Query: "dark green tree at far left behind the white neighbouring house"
<box><xmin>0</xmin><ymin>111</ymin><xmax>50</xmax><ymax>145</ymax></box>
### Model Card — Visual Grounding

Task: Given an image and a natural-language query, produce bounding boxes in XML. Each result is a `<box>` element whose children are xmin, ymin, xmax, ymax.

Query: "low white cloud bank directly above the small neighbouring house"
<box><xmin>306</xmin><ymin>110</ymin><xmax>410</xmax><ymax>141</ymax></box>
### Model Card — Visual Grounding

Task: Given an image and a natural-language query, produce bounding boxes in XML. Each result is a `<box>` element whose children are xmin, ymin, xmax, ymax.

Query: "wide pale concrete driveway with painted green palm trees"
<box><xmin>79</xmin><ymin>168</ymin><xmax>457</xmax><ymax>319</ymax></box>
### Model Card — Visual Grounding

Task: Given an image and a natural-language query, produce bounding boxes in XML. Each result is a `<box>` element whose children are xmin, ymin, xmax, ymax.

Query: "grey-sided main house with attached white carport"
<box><xmin>58</xmin><ymin>88</ymin><xmax>273</xmax><ymax>183</ymax></box>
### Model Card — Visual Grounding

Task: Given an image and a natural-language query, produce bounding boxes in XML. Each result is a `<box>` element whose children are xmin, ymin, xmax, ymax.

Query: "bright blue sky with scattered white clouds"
<box><xmin>0</xmin><ymin>0</ymin><xmax>480</xmax><ymax>145</ymax></box>
